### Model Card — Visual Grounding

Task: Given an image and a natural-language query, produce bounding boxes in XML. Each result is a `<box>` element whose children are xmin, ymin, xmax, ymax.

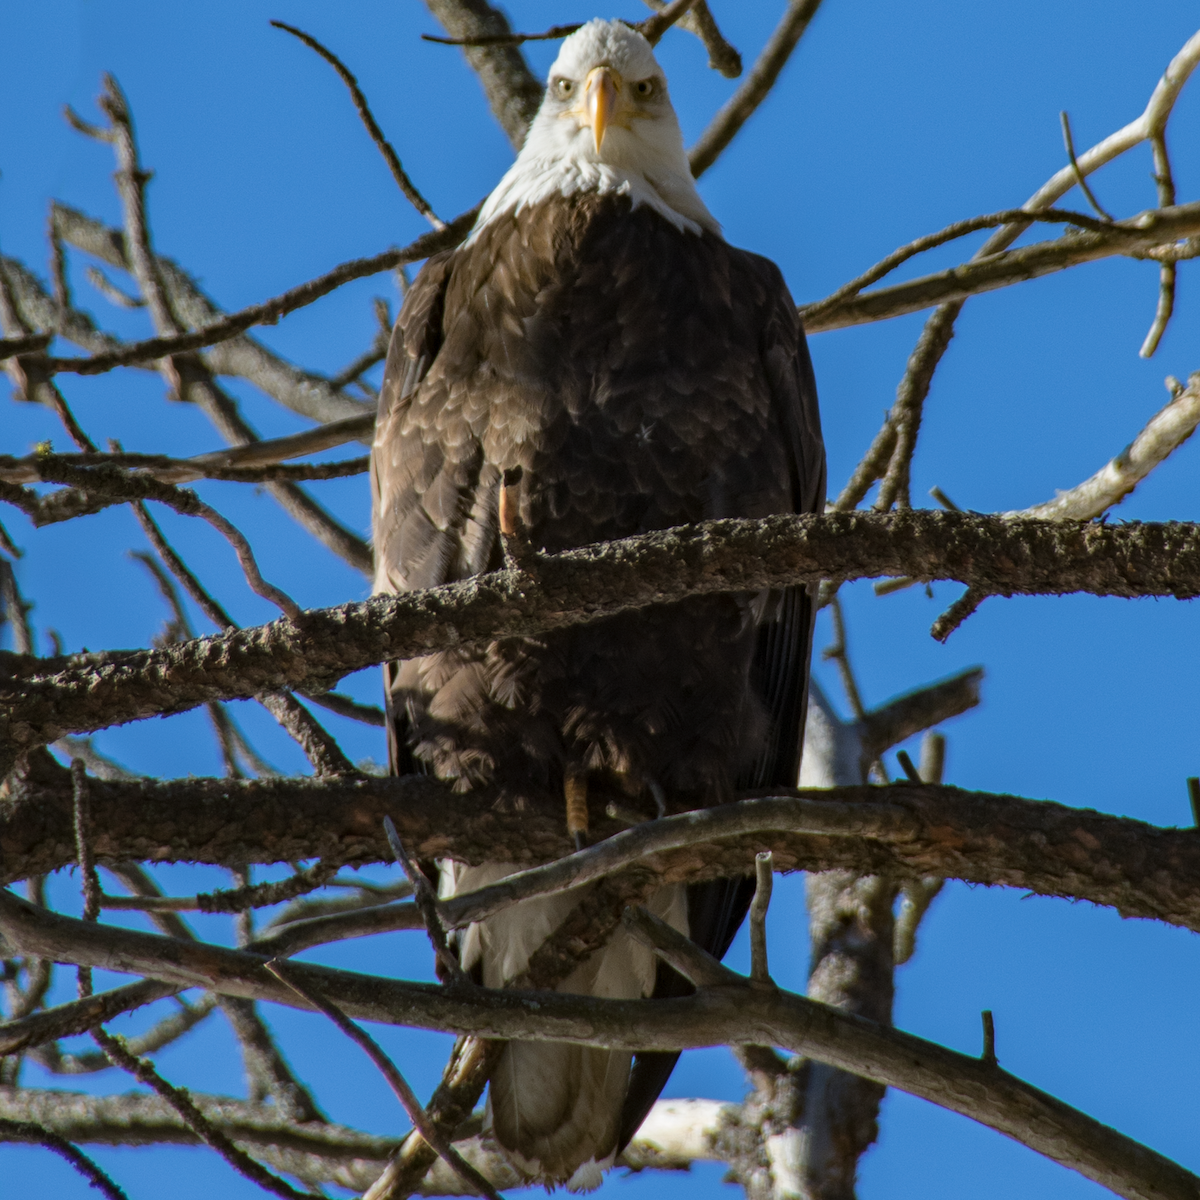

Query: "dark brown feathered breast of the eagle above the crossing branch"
<box><xmin>384</xmin><ymin>196</ymin><xmax>790</xmax><ymax>566</ymax></box>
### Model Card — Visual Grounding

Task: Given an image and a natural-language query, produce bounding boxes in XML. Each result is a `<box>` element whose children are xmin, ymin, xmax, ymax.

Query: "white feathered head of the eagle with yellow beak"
<box><xmin>476</xmin><ymin>19</ymin><xmax>720</xmax><ymax>235</ymax></box>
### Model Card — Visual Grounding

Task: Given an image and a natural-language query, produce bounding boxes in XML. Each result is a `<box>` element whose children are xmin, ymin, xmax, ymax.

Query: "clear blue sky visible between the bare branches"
<box><xmin>0</xmin><ymin>0</ymin><xmax>1200</xmax><ymax>1200</ymax></box>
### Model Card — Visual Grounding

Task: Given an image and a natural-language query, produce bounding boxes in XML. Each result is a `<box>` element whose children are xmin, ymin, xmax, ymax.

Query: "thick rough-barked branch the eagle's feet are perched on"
<box><xmin>0</xmin><ymin>768</ymin><xmax>1200</xmax><ymax>953</ymax></box>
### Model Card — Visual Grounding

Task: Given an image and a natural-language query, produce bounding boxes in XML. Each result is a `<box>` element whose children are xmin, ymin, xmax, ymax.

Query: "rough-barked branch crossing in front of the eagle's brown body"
<box><xmin>0</xmin><ymin>511</ymin><xmax>1200</xmax><ymax>769</ymax></box>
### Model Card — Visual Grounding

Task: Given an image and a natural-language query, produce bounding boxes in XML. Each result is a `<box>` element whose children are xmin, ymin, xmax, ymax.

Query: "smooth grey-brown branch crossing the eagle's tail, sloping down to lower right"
<box><xmin>0</xmin><ymin>893</ymin><xmax>1200</xmax><ymax>1200</ymax></box>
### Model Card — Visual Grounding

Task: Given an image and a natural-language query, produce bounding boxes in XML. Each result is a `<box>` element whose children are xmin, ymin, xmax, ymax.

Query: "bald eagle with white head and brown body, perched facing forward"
<box><xmin>372</xmin><ymin>20</ymin><xmax>824</xmax><ymax>1190</ymax></box>
